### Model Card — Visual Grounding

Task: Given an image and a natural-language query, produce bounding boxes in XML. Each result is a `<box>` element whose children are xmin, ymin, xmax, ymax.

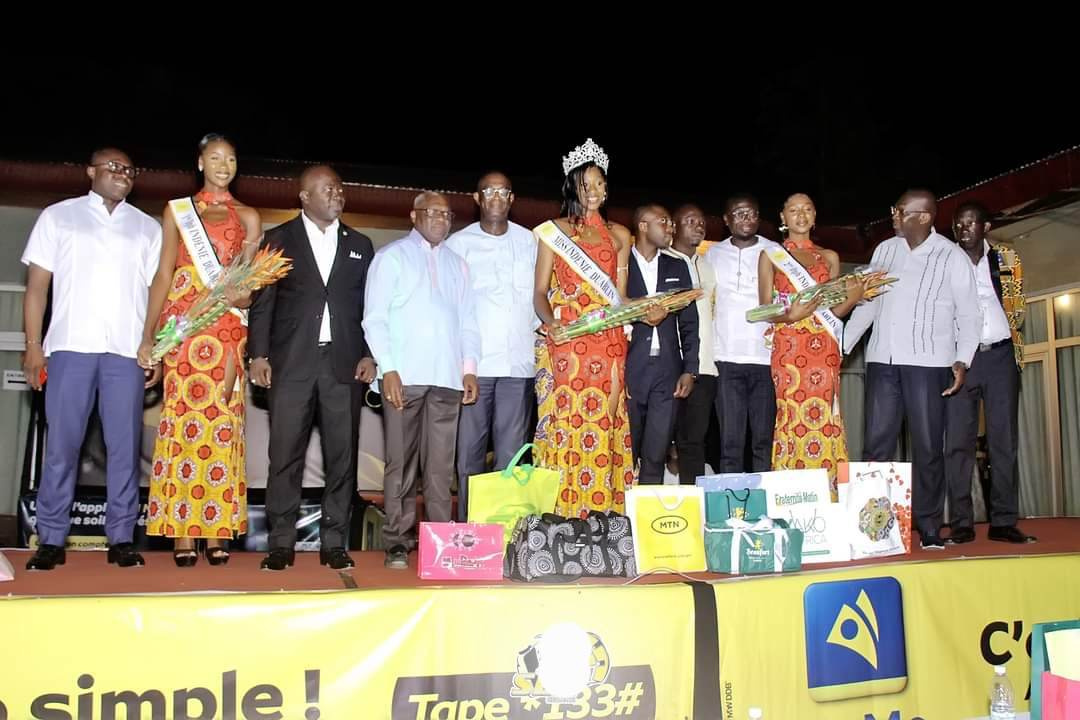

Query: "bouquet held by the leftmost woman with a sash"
<box><xmin>150</xmin><ymin>248</ymin><xmax>293</xmax><ymax>363</ymax></box>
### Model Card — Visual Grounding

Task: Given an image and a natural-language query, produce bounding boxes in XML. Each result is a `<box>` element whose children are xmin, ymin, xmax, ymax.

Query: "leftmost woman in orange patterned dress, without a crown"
<box><xmin>139</xmin><ymin>135</ymin><xmax>261</xmax><ymax>567</ymax></box>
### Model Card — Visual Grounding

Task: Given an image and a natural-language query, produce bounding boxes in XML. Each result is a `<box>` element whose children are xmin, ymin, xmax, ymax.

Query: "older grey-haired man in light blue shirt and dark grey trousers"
<box><xmin>364</xmin><ymin>192</ymin><xmax>481</xmax><ymax>570</ymax></box>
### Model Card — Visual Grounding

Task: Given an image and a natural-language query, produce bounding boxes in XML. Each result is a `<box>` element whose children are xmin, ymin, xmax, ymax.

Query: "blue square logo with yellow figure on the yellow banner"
<box><xmin>802</xmin><ymin>578</ymin><xmax>907</xmax><ymax>703</ymax></box>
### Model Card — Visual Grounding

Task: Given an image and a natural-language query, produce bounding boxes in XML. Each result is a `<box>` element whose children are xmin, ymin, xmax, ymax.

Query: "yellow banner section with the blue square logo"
<box><xmin>716</xmin><ymin>555</ymin><xmax>1080</xmax><ymax>720</ymax></box>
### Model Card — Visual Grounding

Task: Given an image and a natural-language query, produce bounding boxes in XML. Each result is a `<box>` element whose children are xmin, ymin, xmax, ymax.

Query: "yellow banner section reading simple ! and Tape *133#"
<box><xmin>0</xmin><ymin>584</ymin><xmax>693</xmax><ymax>720</ymax></box>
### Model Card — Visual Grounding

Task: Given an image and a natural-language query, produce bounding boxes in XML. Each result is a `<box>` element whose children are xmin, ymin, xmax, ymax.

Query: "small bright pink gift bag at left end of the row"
<box><xmin>417</xmin><ymin>522</ymin><xmax>505</xmax><ymax>580</ymax></box>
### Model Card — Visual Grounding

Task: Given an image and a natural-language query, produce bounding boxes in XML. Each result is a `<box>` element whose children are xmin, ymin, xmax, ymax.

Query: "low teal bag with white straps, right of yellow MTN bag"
<box><xmin>705</xmin><ymin>517</ymin><xmax>802</xmax><ymax>575</ymax></box>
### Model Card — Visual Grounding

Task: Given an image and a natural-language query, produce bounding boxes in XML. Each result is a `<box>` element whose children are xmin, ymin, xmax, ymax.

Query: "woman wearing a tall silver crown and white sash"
<box><xmin>534</xmin><ymin>138</ymin><xmax>662</xmax><ymax>517</ymax></box>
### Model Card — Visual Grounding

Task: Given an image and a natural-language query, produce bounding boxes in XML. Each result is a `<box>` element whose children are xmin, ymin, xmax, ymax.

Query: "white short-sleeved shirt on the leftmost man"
<box><xmin>23</xmin><ymin>192</ymin><xmax>161</xmax><ymax>357</ymax></box>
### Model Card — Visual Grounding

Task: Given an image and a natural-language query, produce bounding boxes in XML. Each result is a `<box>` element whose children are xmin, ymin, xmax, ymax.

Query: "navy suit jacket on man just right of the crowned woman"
<box><xmin>626</xmin><ymin>253</ymin><xmax>699</xmax><ymax>396</ymax></box>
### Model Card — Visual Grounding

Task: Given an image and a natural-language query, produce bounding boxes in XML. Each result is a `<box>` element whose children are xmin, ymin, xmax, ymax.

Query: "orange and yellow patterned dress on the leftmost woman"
<box><xmin>147</xmin><ymin>193</ymin><xmax>247</xmax><ymax>539</ymax></box>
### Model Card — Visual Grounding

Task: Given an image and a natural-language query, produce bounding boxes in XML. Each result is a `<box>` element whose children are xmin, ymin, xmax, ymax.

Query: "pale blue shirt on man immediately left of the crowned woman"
<box><xmin>446</xmin><ymin>222</ymin><xmax>540</xmax><ymax>378</ymax></box>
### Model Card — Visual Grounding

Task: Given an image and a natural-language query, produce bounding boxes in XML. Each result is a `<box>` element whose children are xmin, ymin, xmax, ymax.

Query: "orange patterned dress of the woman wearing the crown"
<box><xmin>536</xmin><ymin>217</ymin><xmax>634</xmax><ymax>517</ymax></box>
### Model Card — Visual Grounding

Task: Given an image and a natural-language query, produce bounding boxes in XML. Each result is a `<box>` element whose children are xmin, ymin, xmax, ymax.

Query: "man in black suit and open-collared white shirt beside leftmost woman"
<box><xmin>247</xmin><ymin>165</ymin><xmax>375</xmax><ymax>570</ymax></box>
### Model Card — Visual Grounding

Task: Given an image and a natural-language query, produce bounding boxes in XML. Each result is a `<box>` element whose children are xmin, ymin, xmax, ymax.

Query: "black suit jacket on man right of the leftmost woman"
<box><xmin>247</xmin><ymin>216</ymin><xmax>375</xmax><ymax>382</ymax></box>
